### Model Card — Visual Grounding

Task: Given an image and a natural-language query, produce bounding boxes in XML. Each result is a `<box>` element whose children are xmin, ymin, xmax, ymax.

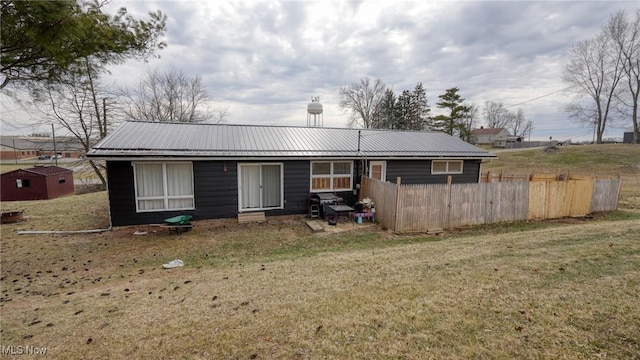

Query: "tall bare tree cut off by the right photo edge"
<box><xmin>604</xmin><ymin>9</ymin><xmax>640</xmax><ymax>144</ymax></box>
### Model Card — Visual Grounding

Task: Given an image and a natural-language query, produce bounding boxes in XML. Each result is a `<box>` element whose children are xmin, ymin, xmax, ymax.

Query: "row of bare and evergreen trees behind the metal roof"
<box><xmin>339</xmin><ymin>77</ymin><xmax>533</xmax><ymax>141</ymax></box>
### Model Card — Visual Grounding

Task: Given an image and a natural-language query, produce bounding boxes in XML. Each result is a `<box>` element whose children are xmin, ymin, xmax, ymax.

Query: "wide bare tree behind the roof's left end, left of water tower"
<box><xmin>120</xmin><ymin>70</ymin><xmax>228</xmax><ymax>123</ymax></box>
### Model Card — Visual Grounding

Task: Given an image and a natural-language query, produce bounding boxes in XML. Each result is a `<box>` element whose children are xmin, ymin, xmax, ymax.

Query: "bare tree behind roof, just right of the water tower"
<box><xmin>340</xmin><ymin>77</ymin><xmax>387</xmax><ymax>129</ymax></box>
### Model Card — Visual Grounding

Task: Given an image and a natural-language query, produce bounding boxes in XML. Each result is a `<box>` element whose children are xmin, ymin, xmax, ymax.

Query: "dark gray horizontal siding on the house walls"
<box><xmin>107</xmin><ymin>160</ymin><xmax>480</xmax><ymax>226</ymax></box>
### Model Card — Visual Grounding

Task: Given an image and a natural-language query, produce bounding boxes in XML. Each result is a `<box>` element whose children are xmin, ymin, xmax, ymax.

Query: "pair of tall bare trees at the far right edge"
<box><xmin>562</xmin><ymin>9</ymin><xmax>640</xmax><ymax>144</ymax></box>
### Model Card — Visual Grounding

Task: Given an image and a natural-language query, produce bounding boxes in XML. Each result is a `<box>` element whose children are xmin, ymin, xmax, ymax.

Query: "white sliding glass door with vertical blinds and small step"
<box><xmin>238</xmin><ymin>164</ymin><xmax>284</xmax><ymax>211</ymax></box>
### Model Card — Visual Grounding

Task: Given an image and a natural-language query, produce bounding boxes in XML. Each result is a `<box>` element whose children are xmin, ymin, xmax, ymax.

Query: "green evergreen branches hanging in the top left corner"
<box><xmin>0</xmin><ymin>0</ymin><xmax>166</xmax><ymax>90</ymax></box>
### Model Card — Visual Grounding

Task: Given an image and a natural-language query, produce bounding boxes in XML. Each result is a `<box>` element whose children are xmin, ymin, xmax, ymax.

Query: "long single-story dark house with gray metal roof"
<box><xmin>87</xmin><ymin>122</ymin><xmax>495</xmax><ymax>226</ymax></box>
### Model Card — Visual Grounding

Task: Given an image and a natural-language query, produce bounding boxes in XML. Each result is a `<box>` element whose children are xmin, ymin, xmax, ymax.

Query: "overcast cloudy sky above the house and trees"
<box><xmin>3</xmin><ymin>0</ymin><xmax>639</xmax><ymax>140</ymax></box>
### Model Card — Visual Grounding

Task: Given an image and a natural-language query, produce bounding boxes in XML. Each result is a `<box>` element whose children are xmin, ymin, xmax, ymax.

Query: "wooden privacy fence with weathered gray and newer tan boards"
<box><xmin>362</xmin><ymin>175</ymin><xmax>620</xmax><ymax>233</ymax></box>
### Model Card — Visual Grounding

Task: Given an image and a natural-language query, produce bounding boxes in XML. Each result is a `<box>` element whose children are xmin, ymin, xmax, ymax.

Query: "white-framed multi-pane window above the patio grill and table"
<box><xmin>311</xmin><ymin>161</ymin><xmax>353</xmax><ymax>191</ymax></box>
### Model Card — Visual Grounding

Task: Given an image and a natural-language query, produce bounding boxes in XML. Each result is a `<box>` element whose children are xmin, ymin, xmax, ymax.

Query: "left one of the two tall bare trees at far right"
<box><xmin>562</xmin><ymin>34</ymin><xmax>624</xmax><ymax>143</ymax></box>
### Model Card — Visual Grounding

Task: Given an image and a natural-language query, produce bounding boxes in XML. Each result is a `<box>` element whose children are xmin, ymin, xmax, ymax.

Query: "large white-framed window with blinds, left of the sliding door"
<box><xmin>133</xmin><ymin>163</ymin><xmax>195</xmax><ymax>212</ymax></box>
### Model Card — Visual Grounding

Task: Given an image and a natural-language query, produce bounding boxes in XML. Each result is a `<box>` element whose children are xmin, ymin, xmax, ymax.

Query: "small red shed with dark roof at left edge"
<box><xmin>0</xmin><ymin>166</ymin><xmax>74</xmax><ymax>201</ymax></box>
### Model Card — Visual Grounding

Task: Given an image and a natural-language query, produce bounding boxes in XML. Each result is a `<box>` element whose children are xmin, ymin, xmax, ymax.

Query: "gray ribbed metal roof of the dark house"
<box><xmin>87</xmin><ymin>121</ymin><xmax>495</xmax><ymax>158</ymax></box>
